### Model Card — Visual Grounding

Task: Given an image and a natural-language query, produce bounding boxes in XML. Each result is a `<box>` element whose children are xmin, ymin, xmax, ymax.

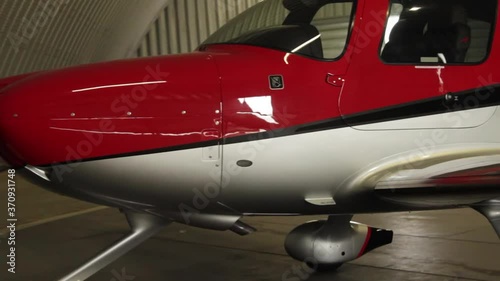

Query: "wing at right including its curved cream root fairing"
<box><xmin>351</xmin><ymin>144</ymin><xmax>500</xmax><ymax>207</ymax></box>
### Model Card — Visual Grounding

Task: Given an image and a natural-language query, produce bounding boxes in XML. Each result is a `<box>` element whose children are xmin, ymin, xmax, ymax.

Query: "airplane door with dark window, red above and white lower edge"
<box><xmin>340</xmin><ymin>0</ymin><xmax>496</xmax><ymax>130</ymax></box>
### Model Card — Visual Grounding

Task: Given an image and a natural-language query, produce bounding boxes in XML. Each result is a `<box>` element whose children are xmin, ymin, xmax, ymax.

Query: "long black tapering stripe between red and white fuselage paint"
<box><xmin>41</xmin><ymin>84</ymin><xmax>500</xmax><ymax>166</ymax></box>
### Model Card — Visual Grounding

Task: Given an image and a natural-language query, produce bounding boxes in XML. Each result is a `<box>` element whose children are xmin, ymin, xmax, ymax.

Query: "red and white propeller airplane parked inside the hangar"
<box><xmin>0</xmin><ymin>0</ymin><xmax>500</xmax><ymax>280</ymax></box>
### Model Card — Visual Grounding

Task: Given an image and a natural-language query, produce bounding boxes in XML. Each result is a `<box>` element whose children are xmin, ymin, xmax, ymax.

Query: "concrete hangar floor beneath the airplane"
<box><xmin>0</xmin><ymin>171</ymin><xmax>500</xmax><ymax>281</ymax></box>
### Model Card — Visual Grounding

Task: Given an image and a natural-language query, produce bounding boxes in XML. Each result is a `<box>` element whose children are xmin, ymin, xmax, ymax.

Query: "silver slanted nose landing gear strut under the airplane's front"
<box><xmin>59</xmin><ymin>211</ymin><xmax>171</xmax><ymax>281</ymax></box>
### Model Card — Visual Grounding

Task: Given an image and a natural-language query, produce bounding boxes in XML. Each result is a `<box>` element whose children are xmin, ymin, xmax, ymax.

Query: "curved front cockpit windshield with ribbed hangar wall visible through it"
<box><xmin>202</xmin><ymin>0</ymin><xmax>355</xmax><ymax>59</ymax></box>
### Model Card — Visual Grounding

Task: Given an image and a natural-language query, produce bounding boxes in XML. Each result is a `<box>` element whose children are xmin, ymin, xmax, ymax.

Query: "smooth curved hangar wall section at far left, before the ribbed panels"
<box><xmin>0</xmin><ymin>0</ymin><xmax>169</xmax><ymax>77</ymax></box>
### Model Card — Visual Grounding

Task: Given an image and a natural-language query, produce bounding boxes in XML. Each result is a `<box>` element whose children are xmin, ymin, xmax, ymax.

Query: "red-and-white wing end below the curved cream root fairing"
<box><xmin>374</xmin><ymin>155</ymin><xmax>500</xmax><ymax>206</ymax></box>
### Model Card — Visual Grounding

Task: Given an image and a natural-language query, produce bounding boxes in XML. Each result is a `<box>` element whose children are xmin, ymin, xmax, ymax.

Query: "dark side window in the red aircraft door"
<box><xmin>380</xmin><ymin>0</ymin><xmax>497</xmax><ymax>64</ymax></box>
